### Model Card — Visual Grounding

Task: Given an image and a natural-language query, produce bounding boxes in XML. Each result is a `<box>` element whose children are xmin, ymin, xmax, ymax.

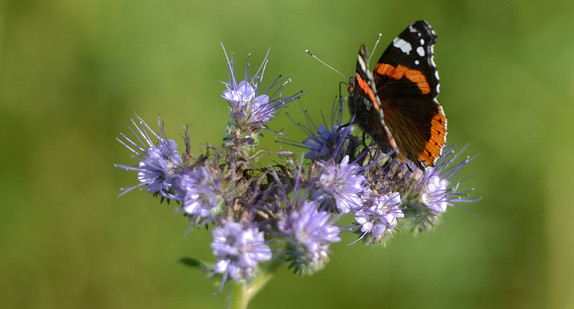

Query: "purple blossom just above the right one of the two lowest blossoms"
<box><xmin>318</xmin><ymin>156</ymin><xmax>365</xmax><ymax>213</ymax></box>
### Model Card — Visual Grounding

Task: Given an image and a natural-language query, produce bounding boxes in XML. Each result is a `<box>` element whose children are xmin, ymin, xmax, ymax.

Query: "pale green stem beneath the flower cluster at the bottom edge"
<box><xmin>228</xmin><ymin>258</ymin><xmax>284</xmax><ymax>309</ymax></box>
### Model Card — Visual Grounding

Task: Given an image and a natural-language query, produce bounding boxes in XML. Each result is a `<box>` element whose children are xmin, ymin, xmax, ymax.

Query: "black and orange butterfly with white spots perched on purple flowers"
<box><xmin>348</xmin><ymin>21</ymin><xmax>446</xmax><ymax>169</ymax></box>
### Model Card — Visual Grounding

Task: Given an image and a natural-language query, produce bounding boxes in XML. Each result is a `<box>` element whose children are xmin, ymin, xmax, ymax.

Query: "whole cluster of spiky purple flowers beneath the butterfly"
<box><xmin>116</xmin><ymin>46</ymin><xmax>480</xmax><ymax>283</ymax></box>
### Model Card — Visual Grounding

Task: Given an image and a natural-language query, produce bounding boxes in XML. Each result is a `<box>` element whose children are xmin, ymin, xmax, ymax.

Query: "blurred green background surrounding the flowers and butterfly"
<box><xmin>0</xmin><ymin>0</ymin><xmax>574</xmax><ymax>308</ymax></box>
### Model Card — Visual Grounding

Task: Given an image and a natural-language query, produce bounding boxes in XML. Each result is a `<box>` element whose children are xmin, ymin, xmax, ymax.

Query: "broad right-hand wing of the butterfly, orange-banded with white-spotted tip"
<box><xmin>373</xmin><ymin>21</ymin><xmax>447</xmax><ymax>167</ymax></box>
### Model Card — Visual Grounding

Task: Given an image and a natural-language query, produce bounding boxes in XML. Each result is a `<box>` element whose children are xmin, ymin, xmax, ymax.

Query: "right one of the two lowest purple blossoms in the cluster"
<box><xmin>279</xmin><ymin>201</ymin><xmax>341</xmax><ymax>273</ymax></box>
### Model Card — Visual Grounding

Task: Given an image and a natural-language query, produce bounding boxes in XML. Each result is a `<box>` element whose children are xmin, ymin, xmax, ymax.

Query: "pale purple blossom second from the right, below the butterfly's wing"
<box><xmin>355</xmin><ymin>192</ymin><xmax>404</xmax><ymax>244</ymax></box>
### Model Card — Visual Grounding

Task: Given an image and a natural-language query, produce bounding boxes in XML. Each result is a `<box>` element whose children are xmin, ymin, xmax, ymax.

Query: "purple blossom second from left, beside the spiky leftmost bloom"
<box><xmin>175</xmin><ymin>166</ymin><xmax>221</xmax><ymax>222</ymax></box>
